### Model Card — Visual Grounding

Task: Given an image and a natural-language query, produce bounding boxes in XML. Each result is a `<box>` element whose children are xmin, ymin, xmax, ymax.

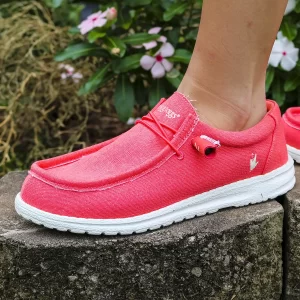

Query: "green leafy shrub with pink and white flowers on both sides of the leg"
<box><xmin>56</xmin><ymin>0</ymin><xmax>300</xmax><ymax>121</ymax></box>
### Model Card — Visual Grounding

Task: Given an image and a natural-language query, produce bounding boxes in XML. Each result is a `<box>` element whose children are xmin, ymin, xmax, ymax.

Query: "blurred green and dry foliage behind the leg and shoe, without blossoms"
<box><xmin>0</xmin><ymin>0</ymin><xmax>300</xmax><ymax>175</ymax></box>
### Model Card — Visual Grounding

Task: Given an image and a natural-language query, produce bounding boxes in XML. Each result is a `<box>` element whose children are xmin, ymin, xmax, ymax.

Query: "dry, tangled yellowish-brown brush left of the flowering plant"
<box><xmin>0</xmin><ymin>1</ymin><xmax>128</xmax><ymax>176</ymax></box>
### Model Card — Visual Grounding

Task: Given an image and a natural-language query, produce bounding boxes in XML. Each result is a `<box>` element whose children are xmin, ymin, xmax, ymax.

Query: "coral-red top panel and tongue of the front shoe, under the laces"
<box><xmin>40</xmin><ymin>93</ymin><xmax>196</xmax><ymax>186</ymax></box>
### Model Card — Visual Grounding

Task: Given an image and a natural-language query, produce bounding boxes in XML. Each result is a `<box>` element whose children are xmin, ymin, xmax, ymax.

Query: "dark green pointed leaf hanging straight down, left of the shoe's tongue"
<box><xmin>114</xmin><ymin>74</ymin><xmax>135</xmax><ymax>122</ymax></box>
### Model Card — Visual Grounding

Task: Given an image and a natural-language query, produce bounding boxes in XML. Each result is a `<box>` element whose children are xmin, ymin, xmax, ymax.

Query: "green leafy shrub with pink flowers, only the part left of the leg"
<box><xmin>55</xmin><ymin>0</ymin><xmax>202</xmax><ymax>122</ymax></box>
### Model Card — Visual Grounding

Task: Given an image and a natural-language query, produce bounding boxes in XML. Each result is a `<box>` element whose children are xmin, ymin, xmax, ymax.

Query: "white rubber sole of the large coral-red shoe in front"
<box><xmin>15</xmin><ymin>157</ymin><xmax>295</xmax><ymax>235</ymax></box>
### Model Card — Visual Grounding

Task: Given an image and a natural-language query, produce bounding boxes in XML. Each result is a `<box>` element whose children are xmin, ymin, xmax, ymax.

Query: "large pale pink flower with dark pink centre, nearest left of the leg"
<box><xmin>140</xmin><ymin>43</ymin><xmax>175</xmax><ymax>78</ymax></box>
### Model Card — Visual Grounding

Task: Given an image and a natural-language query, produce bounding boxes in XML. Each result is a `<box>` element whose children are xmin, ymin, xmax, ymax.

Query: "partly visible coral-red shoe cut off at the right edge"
<box><xmin>282</xmin><ymin>107</ymin><xmax>300</xmax><ymax>163</ymax></box>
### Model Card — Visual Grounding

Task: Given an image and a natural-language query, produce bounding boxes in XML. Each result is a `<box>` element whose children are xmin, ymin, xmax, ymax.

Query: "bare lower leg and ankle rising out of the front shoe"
<box><xmin>178</xmin><ymin>0</ymin><xmax>287</xmax><ymax>131</ymax></box>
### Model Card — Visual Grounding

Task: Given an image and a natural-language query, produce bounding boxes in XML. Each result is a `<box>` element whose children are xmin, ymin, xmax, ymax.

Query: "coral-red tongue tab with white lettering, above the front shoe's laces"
<box><xmin>152</xmin><ymin>92</ymin><xmax>196</xmax><ymax>129</ymax></box>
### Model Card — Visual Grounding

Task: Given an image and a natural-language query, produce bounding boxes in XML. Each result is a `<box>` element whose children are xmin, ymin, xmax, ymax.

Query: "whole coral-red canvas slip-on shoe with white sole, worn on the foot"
<box><xmin>16</xmin><ymin>93</ymin><xmax>295</xmax><ymax>235</ymax></box>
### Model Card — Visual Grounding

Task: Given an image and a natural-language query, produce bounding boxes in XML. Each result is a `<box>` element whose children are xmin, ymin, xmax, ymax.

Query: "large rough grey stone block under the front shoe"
<box><xmin>0</xmin><ymin>172</ymin><xmax>283</xmax><ymax>300</ymax></box>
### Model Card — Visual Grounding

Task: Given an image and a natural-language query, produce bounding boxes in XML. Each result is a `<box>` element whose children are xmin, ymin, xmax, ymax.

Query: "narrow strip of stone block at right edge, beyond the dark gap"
<box><xmin>284</xmin><ymin>165</ymin><xmax>300</xmax><ymax>300</ymax></box>
